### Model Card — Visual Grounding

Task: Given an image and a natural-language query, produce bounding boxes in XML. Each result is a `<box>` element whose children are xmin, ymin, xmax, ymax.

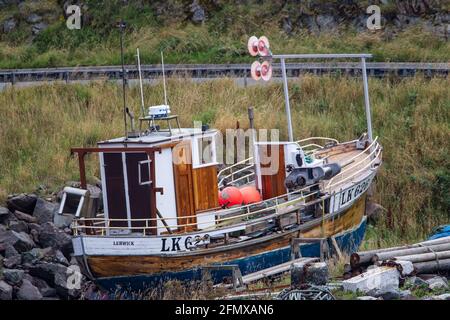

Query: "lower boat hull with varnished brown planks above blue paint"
<box><xmin>78</xmin><ymin>195</ymin><xmax>366</xmax><ymax>289</ymax></box>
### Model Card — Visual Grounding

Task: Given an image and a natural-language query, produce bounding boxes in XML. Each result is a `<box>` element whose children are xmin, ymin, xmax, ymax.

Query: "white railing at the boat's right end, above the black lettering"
<box><xmin>325</xmin><ymin>137</ymin><xmax>383</xmax><ymax>191</ymax></box>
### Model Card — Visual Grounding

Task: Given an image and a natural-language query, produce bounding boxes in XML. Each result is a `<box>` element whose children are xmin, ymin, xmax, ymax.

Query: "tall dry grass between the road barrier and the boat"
<box><xmin>0</xmin><ymin>76</ymin><xmax>450</xmax><ymax>245</ymax></box>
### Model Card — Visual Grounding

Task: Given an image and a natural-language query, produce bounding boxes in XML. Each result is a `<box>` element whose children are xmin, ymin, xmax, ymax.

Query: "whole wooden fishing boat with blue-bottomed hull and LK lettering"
<box><xmin>60</xmin><ymin>37</ymin><xmax>382</xmax><ymax>288</ymax></box>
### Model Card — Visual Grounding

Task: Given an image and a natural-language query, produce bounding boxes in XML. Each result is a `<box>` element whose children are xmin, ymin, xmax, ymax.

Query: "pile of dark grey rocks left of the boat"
<box><xmin>0</xmin><ymin>194</ymin><xmax>87</xmax><ymax>300</ymax></box>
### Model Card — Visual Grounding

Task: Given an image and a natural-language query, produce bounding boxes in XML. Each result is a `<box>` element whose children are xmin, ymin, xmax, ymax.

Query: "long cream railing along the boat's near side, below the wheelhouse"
<box><xmin>72</xmin><ymin>184</ymin><xmax>320</xmax><ymax>235</ymax></box>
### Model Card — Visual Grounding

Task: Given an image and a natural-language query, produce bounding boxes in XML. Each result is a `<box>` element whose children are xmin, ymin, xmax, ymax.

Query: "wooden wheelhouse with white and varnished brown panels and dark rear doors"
<box><xmin>72</xmin><ymin>129</ymin><xmax>218</xmax><ymax>234</ymax></box>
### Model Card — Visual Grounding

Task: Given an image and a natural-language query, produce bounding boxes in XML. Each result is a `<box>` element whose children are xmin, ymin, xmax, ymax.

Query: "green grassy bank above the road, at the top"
<box><xmin>0</xmin><ymin>0</ymin><xmax>450</xmax><ymax>68</ymax></box>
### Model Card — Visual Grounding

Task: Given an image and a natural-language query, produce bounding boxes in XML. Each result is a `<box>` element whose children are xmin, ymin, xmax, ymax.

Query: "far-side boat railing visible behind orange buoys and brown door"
<box><xmin>217</xmin><ymin>137</ymin><xmax>339</xmax><ymax>187</ymax></box>
